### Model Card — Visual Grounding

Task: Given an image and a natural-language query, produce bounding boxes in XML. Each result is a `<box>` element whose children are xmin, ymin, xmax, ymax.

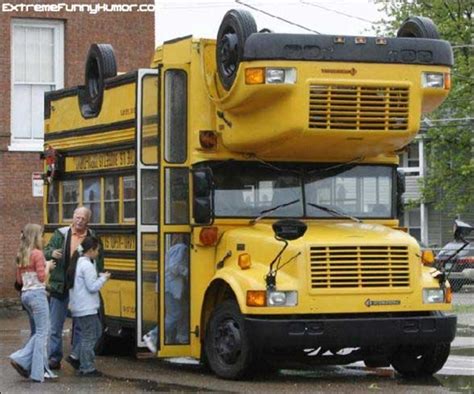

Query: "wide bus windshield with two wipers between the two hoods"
<box><xmin>213</xmin><ymin>162</ymin><xmax>396</xmax><ymax>218</ymax></box>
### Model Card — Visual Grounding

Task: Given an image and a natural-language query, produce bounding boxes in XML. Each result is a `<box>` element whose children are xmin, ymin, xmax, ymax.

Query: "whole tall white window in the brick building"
<box><xmin>9</xmin><ymin>19</ymin><xmax>64</xmax><ymax>151</ymax></box>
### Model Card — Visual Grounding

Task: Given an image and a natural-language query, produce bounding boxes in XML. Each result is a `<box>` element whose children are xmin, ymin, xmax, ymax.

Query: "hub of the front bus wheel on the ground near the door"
<box><xmin>214</xmin><ymin>319</ymin><xmax>242</xmax><ymax>364</ymax></box>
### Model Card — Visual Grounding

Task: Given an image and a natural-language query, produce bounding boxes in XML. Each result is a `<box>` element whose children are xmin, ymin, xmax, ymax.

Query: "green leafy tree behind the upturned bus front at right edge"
<box><xmin>375</xmin><ymin>0</ymin><xmax>474</xmax><ymax>214</ymax></box>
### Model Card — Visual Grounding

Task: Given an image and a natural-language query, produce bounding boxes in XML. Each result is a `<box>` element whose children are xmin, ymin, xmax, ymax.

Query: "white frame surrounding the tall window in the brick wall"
<box><xmin>8</xmin><ymin>19</ymin><xmax>64</xmax><ymax>152</ymax></box>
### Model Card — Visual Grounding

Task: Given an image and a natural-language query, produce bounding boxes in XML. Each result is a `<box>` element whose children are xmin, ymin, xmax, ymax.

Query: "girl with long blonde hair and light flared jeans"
<box><xmin>10</xmin><ymin>224</ymin><xmax>57</xmax><ymax>382</ymax></box>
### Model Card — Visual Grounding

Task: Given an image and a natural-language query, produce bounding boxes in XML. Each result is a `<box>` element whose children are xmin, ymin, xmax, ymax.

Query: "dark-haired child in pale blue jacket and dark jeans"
<box><xmin>66</xmin><ymin>236</ymin><xmax>110</xmax><ymax>376</ymax></box>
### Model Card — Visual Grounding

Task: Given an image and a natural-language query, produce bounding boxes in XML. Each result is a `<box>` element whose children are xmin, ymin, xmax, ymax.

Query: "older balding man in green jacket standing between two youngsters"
<box><xmin>44</xmin><ymin>207</ymin><xmax>104</xmax><ymax>369</ymax></box>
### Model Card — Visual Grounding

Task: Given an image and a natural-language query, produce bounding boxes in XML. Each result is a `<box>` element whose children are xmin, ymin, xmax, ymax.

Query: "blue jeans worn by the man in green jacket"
<box><xmin>48</xmin><ymin>297</ymin><xmax>81</xmax><ymax>362</ymax></box>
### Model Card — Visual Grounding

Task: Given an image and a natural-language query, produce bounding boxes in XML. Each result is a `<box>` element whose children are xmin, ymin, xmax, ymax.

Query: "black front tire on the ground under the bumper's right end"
<box><xmin>391</xmin><ymin>343</ymin><xmax>451</xmax><ymax>378</ymax></box>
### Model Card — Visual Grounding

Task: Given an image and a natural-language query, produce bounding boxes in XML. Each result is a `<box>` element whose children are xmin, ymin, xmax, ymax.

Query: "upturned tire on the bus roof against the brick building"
<box><xmin>85</xmin><ymin>44</ymin><xmax>117</xmax><ymax>116</ymax></box>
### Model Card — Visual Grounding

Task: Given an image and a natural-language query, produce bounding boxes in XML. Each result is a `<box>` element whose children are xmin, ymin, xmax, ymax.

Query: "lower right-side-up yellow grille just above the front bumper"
<box><xmin>310</xmin><ymin>246</ymin><xmax>410</xmax><ymax>289</ymax></box>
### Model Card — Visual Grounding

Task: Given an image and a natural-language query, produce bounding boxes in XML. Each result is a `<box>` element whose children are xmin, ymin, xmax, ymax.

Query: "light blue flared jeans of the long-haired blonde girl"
<box><xmin>10</xmin><ymin>289</ymin><xmax>49</xmax><ymax>382</ymax></box>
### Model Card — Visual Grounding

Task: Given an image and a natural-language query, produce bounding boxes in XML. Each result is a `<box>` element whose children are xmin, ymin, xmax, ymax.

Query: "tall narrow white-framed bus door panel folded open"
<box><xmin>135</xmin><ymin>69</ymin><xmax>160</xmax><ymax>347</ymax></box>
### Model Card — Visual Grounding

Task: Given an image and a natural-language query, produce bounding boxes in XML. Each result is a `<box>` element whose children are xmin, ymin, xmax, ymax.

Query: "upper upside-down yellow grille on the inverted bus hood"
<box><xmin>309</xmin><ymin>85</ymin><xmax>409</xmax><ymax>131</ymax></box>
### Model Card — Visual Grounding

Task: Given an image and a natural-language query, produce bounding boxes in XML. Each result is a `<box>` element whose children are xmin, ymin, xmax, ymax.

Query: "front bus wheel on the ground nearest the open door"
<box><xmin>205</xmin><ymin>300</ymin><xmax>254</xmax><ymax>380</ymax></box>
